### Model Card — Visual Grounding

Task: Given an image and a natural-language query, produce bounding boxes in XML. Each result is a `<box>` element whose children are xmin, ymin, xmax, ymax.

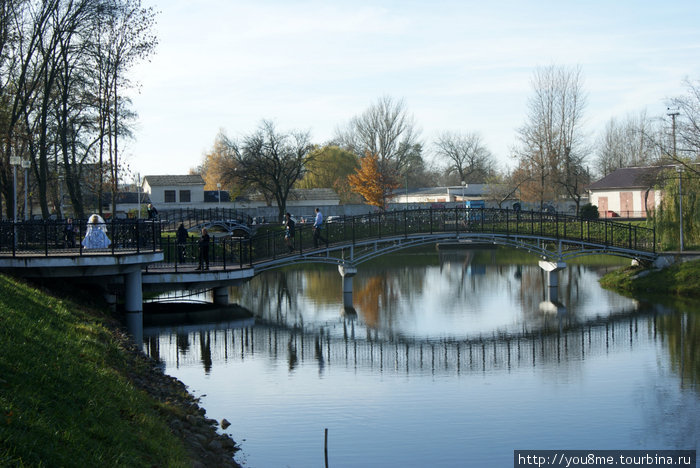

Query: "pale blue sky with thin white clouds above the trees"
<box><xmin>122</xmin><ymin>0</ymin><xmax>700</xmax><ymax>180</ymax></box>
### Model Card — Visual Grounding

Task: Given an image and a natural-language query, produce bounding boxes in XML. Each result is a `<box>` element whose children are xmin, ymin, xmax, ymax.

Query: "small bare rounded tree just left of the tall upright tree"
<box><xmin>434</xmin><ymin>132</ymin><xmax>495</xmax><ymax>183</ymax></box>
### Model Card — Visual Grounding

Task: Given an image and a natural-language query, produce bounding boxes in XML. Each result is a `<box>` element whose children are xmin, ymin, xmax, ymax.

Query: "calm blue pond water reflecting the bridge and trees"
<box><xmin>144</xmin><ymin>249</ymin><xmax>700</xmax><ymax>467</ymax></box>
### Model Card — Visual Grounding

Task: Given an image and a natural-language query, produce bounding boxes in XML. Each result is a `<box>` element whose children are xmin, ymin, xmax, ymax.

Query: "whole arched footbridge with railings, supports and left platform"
<box><xmin>0</xmin><ymin>207</ymin><xmax>657</xmax><ymax>322</ymax></box>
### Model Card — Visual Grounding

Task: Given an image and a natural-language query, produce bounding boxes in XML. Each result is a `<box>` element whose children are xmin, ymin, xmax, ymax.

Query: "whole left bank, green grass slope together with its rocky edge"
<box><xmin>0</xmin><ymin>275</ymin><xmax>241</xmax><ymax>468</ymax></box>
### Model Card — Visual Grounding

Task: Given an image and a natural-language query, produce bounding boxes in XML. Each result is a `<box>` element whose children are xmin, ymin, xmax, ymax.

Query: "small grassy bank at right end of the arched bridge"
<box><xmin>600</xmin><ymin>260</ymin><xmax>700</xmax><ymax>298</ymax></box>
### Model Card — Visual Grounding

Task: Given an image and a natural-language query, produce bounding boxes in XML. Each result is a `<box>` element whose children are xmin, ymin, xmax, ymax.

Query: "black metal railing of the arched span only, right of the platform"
<box><xmin>152</xmin><ymin>207</ymin><xmax>656</xmax><ymax>268</ymax></box>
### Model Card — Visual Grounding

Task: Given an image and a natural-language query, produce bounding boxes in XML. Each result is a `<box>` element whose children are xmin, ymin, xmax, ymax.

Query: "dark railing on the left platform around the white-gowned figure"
<box><xmin>0</xmin><ymin>219</ymin><xmax>161</xmax><ymax>257</ymax></box>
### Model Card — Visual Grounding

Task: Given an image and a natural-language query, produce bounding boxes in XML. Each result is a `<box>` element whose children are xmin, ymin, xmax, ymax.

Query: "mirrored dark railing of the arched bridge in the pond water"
<box><xmin>144</xmin><ymin>311</ymin><xmax>668</xmax><ymax>374</ymax></box>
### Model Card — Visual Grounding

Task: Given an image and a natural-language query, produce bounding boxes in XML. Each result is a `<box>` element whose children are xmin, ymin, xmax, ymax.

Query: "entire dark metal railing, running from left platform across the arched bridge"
<box><xmin>0</xmin><ymin>207</ymin><xmax>656</xmax><ymax>269</ymax></box>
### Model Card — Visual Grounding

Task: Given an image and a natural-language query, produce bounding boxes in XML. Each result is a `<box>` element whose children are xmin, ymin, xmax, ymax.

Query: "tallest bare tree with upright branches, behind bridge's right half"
<box><xmin>515</xmin><ymin>66</ymin><xmax>588</xmax><ymax>207</ymax></box>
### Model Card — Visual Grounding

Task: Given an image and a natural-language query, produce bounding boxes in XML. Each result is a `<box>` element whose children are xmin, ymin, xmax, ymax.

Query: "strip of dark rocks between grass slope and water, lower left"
<box><xmin>115</xmin><ymin>330</ymin><xmax>241</xmax><ymax>468</ymax></box>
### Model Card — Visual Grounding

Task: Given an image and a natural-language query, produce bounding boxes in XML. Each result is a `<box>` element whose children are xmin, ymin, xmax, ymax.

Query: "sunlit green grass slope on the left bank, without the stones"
<box><xmin>0</xmin><ymin>275</ymin><xmax>189</xmax><ymax>467</ymax></box>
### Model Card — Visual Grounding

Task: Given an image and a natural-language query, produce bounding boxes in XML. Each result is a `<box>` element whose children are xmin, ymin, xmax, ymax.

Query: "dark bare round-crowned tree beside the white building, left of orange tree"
<box><xmin>228</xmin><ymin>120</ymin><xmax>313</xmax><ymax>221</ymax></box>
